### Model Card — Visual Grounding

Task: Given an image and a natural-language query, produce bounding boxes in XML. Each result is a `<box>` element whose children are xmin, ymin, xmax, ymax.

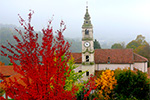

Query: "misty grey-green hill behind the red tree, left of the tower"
<box><xmin>0</xmin><ymin>24</ymin><xmax>82</xmax><ymax>65</ymax></box>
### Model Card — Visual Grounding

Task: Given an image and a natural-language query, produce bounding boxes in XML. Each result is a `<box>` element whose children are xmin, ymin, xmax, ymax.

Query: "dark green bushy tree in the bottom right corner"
<box><xmin>114</xmin><ymin>69</ymin><xmax>150</xmax><ymax>100</ymax></box>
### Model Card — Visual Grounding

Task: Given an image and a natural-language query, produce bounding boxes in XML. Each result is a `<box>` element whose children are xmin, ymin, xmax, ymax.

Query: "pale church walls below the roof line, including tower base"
<box><xmin>75</xmin><ymin>62</ymin><xmax>147</xmax><ymax>78</ymax></box>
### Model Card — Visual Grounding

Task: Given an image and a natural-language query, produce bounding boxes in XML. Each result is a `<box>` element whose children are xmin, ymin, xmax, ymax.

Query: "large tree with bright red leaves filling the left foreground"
<box><xmin>1</xmin><ymin>11</ymin><xmax>77</xmax><ymax>100</ymax></box>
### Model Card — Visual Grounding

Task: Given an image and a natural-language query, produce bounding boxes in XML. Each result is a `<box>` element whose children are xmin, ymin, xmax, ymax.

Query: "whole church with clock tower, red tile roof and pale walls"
<box><xmin>72</xmin><ymin>6</ymin><xmax>148</xmax><ymax>80</ymax></box>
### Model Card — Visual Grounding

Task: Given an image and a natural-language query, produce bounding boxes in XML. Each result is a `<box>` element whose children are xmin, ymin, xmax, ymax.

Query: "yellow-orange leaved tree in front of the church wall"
<box><xmin>95</xmin><ymin>69</ymin><xmax>117</xmax><ymax>100</ymax></box>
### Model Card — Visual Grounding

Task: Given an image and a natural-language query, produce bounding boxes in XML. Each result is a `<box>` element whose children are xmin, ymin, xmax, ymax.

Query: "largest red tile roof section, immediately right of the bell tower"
<box><xmin>94</xmin><ymin>49</ymin><xmax>134</xmax><ymax>64</ymax></box>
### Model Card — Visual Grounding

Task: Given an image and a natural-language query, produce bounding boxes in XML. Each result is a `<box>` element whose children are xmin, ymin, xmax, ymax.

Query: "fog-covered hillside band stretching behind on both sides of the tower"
<box><xmin>0</xmin><ymin>24</ymin><xmax>150</xmax><ymax>64</ymax></box>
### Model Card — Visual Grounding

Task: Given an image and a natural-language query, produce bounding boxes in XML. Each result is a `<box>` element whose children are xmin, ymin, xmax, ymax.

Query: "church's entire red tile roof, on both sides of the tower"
<box><xmin>72</xmin><ymin>49</ymin><xmax>148</xmax><ymax>64</ymax></box>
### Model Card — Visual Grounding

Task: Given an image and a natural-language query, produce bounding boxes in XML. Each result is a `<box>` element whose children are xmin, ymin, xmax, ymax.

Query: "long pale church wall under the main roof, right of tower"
<box><xmin>95</xmin><ymin>64</ymin><xmax>133</xmax><ymax>70</ymax></box>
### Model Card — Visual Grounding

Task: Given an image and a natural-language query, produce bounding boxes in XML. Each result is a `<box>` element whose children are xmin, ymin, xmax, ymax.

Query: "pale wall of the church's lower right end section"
<box><xmin>133</xmin><ymin>62</ymin><xmax>147</xmax><ymax>72</ymax></box>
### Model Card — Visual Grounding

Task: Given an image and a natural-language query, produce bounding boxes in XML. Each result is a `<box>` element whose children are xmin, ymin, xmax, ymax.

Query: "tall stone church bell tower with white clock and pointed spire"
<box><xmin>82</xmin><ymin>6</ymin><xmax>95</xmax><ymax>80</ymax></box>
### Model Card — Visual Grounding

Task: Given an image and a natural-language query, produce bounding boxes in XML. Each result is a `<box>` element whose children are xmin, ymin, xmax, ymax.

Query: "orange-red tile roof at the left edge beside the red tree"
<box><xmin>0</xmin><ymin>66</ymin><xmax>16</xmax><ymax>77</ymax></box>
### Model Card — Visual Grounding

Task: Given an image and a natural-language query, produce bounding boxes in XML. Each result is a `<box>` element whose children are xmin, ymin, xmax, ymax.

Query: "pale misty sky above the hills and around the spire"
<box><xmin>0</xmin><ymin>0</ymin><xmax>150</xmax><ymax>42</ymax></box>
